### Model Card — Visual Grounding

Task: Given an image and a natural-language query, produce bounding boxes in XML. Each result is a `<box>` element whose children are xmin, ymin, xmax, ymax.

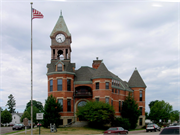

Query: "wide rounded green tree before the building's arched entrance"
<box><xmin>76</xmin><ymin>101</ymin><xmax>115</xmax><ymax>127</ymax></box>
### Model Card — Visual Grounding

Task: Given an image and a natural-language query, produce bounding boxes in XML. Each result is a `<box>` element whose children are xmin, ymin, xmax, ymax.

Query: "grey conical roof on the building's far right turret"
<box><xmin>128</xmin><ymin>69</ymin><xmax>146</xmax><ymax>88</ymax></box>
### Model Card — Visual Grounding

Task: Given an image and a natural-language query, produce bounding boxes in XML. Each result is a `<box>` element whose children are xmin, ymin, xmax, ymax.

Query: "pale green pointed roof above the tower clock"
<box><xmin>50</xmin><ymin>13</ymin><xmax>71</xmax><ymax>38</ymax></box>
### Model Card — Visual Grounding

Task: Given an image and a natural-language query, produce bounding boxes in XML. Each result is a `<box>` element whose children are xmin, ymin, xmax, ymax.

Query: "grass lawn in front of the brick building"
<box><xmin>18</xmin><ymin>127</ymin><xmax>105</xmax><ymax>135</ymax></box>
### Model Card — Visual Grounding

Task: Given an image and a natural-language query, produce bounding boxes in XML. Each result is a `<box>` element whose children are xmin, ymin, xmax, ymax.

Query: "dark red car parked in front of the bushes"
<box><xmin>104</xmin><ymin>127</ymin><xmax>128</xmax><ymax>135</ymax></box>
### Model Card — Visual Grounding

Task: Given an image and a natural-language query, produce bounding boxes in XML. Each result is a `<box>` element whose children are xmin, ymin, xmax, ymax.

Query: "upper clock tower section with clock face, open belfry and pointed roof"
<box><xmin>50</xmin><ymin>13</ymin><xmax>72</xmax><ymax>60</ymax></box>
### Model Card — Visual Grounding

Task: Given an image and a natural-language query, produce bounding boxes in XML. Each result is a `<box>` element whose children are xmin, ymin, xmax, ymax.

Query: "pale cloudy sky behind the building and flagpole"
<box><xmin>0</xmin><ymin>0</ymin><xmax>180</xmax><ymax>113</ymax></box>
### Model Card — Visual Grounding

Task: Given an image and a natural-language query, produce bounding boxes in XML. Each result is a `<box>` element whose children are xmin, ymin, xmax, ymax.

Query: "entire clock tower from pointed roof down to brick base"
<box><xmin>46</xmin><ymin>13</ymin><xmax>75</xmax><ymax>125</ymax></box>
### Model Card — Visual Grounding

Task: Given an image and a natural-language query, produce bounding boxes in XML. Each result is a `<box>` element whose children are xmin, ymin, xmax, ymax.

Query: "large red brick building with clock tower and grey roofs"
<box><xmin>47</xmin><ymin>15</ymin><xmax>146</xmax><ymax>126</ymax></box>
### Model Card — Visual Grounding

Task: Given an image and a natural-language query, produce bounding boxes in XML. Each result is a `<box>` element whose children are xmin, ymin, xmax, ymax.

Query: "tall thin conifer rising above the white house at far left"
<box><xmin>6</xmin><ymin>94</ymin><xmax>16</xmax><ymax>113</ymax></box>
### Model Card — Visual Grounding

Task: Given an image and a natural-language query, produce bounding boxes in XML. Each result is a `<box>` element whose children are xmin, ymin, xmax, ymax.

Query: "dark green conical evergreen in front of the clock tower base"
<box><xmin>43</xmin><ymin>95</ymin><xmax>62</xmax><ymax>128</ymax></box>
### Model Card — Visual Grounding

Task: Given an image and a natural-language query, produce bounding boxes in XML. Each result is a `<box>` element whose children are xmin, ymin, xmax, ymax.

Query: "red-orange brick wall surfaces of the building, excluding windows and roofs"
<box><xmin>48</xmin><ymin>74</ymin><xmax>145</xmax><ymax>116</ymax></box>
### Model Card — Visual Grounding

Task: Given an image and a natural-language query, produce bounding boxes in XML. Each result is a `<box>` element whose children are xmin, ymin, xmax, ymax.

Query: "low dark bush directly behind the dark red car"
<box><xmin>111</xmin><ymin>118</ymin><xmax>131</xmax><ymax>130</ymax></box>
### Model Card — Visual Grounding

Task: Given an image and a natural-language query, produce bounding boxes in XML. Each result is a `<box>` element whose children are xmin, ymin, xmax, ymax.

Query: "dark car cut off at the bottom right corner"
<box><xmin>159</xmin><ymin>126</ymin><xmax>180</xmax><ymax>135</ymax></box>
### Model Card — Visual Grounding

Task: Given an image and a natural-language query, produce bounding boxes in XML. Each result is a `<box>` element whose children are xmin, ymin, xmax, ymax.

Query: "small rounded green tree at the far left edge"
<box><xmin>1</xmin><ymin>109</ymin><xmax>12</xmax><ymax>123</ymax></box>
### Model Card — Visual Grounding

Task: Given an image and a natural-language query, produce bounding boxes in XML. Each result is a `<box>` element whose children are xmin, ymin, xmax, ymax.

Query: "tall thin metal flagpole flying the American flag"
<box><xmin>31</xmin><ymin>2</ymin><xmax>33</xmax><ymax>135</ymax></box>
